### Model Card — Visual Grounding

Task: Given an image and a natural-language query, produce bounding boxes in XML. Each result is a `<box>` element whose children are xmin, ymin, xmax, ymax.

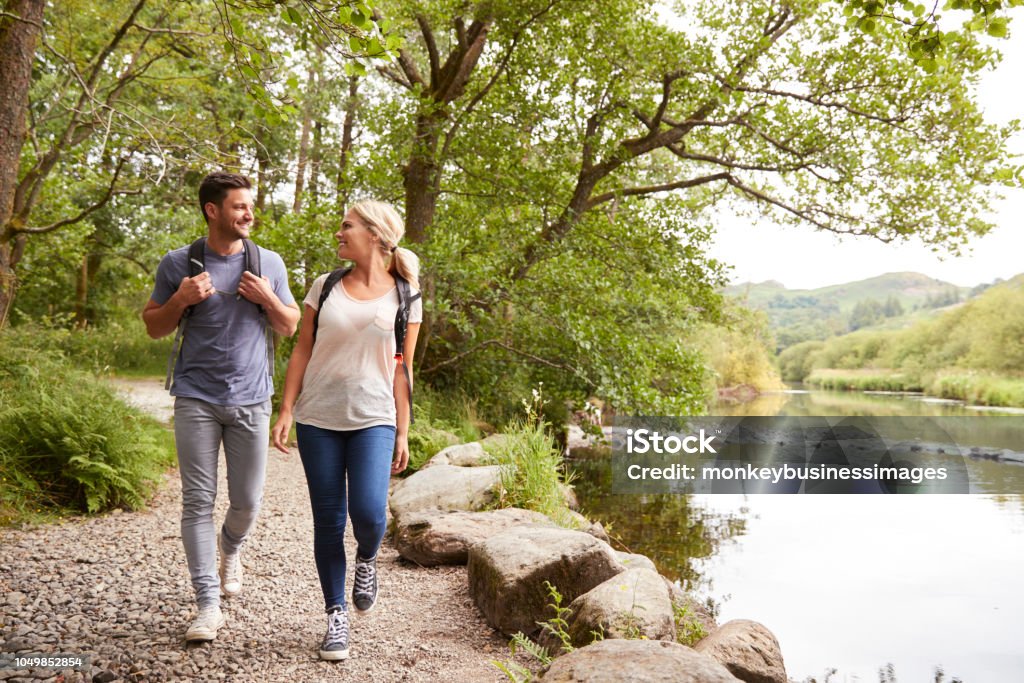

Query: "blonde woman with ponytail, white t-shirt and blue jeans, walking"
<box><xmin>271</xmin><ymin>201</ymin><xmax>423</xmax><ymax>659</ymax></box>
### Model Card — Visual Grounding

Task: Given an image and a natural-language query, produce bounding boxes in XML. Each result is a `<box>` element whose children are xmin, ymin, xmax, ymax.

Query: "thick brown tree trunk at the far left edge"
<box><xmin>0</xmin><ymin>0</ymin><xmax>46</xmax><ymax>329</ymax></box>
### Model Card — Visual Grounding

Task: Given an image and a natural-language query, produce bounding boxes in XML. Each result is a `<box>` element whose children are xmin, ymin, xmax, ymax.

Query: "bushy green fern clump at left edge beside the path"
<box><xmin>0</xmin><ymin>329</ymin><xmax>174</xmax><ymax>521</ymax></box>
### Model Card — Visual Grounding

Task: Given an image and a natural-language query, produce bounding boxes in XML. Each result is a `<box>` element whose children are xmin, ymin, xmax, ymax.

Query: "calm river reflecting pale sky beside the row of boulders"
<box><xmin>572</xmin><ymin>390</ymin><xmax>1024</xmax><ymax>683</ymax></box>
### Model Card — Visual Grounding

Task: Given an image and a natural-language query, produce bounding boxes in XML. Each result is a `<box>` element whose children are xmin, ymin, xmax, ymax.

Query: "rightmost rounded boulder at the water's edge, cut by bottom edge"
<box><xmin>694</xmin><ymin>620</ymin><xmax>787</xmax><ymax>683</ymax></box>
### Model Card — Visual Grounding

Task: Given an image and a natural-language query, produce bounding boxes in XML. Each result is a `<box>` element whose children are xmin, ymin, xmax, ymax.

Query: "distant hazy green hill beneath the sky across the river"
<box><xmin>725</xmin><ymin>272</ymin><xmax>985</xmax><ymax>349</ymax></box>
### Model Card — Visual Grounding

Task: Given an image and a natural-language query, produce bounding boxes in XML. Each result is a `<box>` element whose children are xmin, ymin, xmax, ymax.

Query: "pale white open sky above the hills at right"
<box><xmin>712</xmin><ymin>36</ymin><xmax>1024</xmax><ymax>289</ymax></box>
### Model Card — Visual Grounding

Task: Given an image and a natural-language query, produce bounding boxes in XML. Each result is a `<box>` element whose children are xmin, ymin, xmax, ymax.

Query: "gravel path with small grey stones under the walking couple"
<box><xmin>0</xmin><ymin>380</ymin><xmax>508</xmax><ymax>683</ymax></box>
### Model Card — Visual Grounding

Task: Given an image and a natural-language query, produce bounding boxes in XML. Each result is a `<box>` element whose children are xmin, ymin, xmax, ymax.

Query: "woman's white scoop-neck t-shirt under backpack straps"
<box><xmin>295</xmin><ymin>274</ymin><xmax>423</xmax><ymax>431</ymax></box>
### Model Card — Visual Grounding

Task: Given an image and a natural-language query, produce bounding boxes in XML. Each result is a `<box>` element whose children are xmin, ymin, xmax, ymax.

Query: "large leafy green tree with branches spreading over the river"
<box><xmin>354</xmin><ymin>1</ymin><xmax>1016</xmax><ymax>410</ymax></box>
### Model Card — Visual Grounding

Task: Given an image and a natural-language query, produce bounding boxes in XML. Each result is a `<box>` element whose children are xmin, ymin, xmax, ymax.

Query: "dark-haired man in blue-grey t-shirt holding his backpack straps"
<box><xmin>142</xmin><ymin>173</ymin><xmax>299</xmax><ymax>641</ymax></box>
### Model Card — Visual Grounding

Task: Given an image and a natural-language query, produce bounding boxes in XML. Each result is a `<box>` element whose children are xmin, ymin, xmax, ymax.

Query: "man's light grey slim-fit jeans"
<box><xmin>174</xmin><ymin>396</ymin><xmax>270</xmax><ymax>607</ymax></box>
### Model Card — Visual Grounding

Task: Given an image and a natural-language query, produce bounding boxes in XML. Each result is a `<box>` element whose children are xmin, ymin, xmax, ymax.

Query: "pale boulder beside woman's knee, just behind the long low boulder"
<box><xmin>389</xmin><ymin>465</ymin><xmax>502</xmax><ymax>523</ymax></box>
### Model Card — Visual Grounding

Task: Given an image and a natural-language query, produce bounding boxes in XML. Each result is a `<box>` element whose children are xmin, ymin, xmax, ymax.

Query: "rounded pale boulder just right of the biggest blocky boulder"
<box><xmin>567</xmin><ymin>568</ymin><xmax>676</xmax><ymax>647</ymax></box>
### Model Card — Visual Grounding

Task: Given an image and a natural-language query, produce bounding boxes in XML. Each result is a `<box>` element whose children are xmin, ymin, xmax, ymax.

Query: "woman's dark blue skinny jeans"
<box><xmin>295</xmin><ymin>423</ymin><xmax>394</xmax><ymax>608</ymax></box>
